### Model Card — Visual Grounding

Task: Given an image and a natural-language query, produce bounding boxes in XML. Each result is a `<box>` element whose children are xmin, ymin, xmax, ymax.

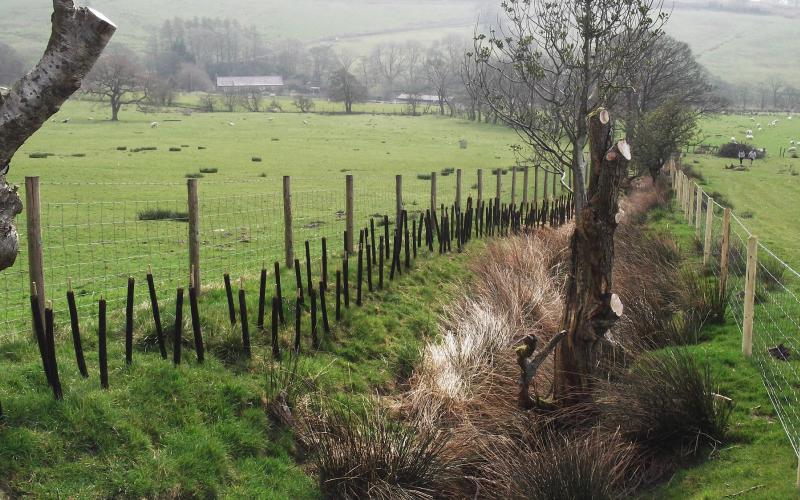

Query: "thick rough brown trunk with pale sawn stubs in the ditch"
<box><xmin>554</xmin><ymin>109</ymin><xmax>631</xmax><ymax>405</ymax></box>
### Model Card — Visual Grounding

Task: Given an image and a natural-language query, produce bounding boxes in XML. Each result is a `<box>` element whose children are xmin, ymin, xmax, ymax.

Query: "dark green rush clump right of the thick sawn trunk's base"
<box><xmin>596</xmin><ymin>349</ymin><xmax>731</xmax><ymax>455</ymax></box>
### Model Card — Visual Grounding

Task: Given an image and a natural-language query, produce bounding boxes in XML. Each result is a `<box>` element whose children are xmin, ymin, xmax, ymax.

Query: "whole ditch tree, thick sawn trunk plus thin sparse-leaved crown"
<box><xmin>469</xmin><ymin>0</ymin><xmax>667</xmax><ymax>405</ymax></box>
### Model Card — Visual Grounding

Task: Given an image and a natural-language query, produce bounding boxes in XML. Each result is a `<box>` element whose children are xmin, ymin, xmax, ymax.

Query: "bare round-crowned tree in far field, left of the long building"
<box><xmin>85</xmin><ymin>47</ymin><xmax>147</xmax><ymax>122</ymax></box>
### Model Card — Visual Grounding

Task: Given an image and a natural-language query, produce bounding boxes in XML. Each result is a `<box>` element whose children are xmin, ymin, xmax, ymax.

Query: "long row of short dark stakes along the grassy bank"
<box><xmin>23</xmin><ymin>196</ymin><xmax>572</xmax><ymax>402</ymax></box>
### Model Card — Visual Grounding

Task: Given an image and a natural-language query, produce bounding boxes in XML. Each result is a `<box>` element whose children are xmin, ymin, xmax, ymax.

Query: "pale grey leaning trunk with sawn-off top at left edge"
<box><xmin>0</xmin><ymin>0</ymin><xmax>117</xmax><ymax>270</ymax></box>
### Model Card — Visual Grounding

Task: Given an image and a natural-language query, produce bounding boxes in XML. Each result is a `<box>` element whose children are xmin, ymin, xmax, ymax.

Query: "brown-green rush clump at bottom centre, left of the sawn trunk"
<box><xmin>299</xmin><ymin>402</ymin><xmax>455</xmax><ymax>499</ymax></box>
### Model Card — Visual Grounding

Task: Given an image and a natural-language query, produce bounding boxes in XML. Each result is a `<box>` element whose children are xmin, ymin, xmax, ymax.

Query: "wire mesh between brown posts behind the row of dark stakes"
<box><xmin>0</xmin><ymin>168</ymin><xmax>565</xmax><ymax>341</ymax></box>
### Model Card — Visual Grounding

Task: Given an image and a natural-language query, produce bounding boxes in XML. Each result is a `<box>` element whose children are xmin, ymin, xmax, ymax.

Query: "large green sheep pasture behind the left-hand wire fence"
<box><xmin>0</xmin><ymin>97</ymin><xmax>564</xmax><ymax>335</ymax></box>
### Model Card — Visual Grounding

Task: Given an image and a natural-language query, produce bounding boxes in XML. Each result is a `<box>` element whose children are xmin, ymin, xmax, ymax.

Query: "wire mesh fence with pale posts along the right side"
<box><xmin>673</xmin><ymin>167</ymin><xmax>800</xmax><ymax>470</ymax></box>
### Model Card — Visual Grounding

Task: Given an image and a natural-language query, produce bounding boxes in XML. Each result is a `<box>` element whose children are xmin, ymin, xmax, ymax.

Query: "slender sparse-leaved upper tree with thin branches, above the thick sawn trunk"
<box><xmin>471</xmin><ymin>0</ymin><xmax>667</xmax><ymax>217</ymax></box>
